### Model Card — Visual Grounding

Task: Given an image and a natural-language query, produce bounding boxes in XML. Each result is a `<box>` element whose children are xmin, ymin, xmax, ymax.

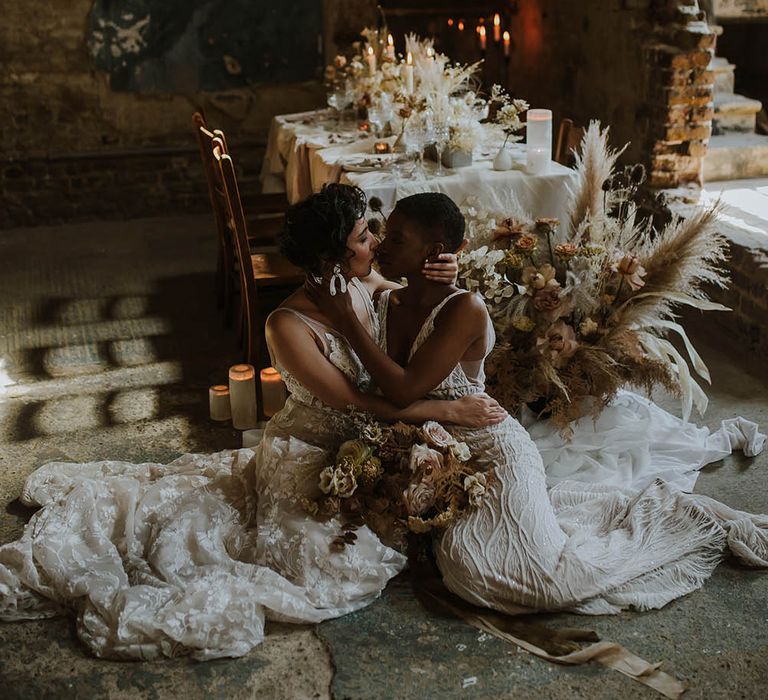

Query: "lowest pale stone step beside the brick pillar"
<box><xmin>704</xmin><ymin>133</ymin><xmax>768</xmax><ymax>182</ymax></box>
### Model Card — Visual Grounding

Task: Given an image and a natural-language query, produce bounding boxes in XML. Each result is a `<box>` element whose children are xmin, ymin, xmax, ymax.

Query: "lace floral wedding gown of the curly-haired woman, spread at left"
<box><xmin>0</xmin><ymin>280</ymin><xmax>406</xmax><ymax>659</ymax></box>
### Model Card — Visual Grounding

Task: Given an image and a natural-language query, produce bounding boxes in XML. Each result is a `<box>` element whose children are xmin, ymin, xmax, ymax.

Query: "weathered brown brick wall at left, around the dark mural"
<box><xmin>0</xmin><ymin>0</ymin><xmax>323</xmax><ymax>228</ymax></box>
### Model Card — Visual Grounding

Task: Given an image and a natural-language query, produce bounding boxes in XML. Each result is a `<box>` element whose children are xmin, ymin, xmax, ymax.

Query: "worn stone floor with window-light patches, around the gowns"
<box><xmin>0</xmin><ymin>217</ymin><xmax>768</xmax><ymax>700</ymax></box>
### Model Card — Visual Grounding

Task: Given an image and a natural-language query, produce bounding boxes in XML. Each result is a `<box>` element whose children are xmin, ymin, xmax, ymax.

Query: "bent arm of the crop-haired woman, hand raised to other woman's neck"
<box><xmin>317</xmin><ymin>294</ymin><xmax>488</xmax><ymax>407</ymax></box>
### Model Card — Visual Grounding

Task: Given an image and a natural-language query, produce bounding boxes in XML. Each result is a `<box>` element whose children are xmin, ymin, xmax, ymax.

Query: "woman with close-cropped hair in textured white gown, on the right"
<box><xmin>312</xmin><ymin>193</ymin><xmax>768</xmax><ymax>614</ymax></box>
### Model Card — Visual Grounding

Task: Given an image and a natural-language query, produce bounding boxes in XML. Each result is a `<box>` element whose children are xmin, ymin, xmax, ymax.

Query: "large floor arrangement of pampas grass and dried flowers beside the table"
<box><xmin>459</xmin><ymin>122</ymin><xmax>727</xmax><ymax>435</ymax></box>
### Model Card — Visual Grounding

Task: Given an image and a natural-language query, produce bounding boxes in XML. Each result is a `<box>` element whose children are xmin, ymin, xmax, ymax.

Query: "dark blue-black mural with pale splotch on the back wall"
<box><xmin>88</xmin><ymin>0</ymin><xmax>322</xmax><ymax>92</ymax></box>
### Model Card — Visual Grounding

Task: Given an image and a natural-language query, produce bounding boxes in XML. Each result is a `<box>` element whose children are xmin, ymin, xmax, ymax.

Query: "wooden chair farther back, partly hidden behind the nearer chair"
<box><xmin>192</xmin><ymin>112</ymin><xmax>288</xmax><ymax>323</ymax></box>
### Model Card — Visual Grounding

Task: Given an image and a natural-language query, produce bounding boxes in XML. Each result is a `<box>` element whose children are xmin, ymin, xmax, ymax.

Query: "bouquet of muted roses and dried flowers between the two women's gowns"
<box><xmin>302</xmin><ymin>414</ymin><xmax>492</xmax><ymax>548</ymax></box>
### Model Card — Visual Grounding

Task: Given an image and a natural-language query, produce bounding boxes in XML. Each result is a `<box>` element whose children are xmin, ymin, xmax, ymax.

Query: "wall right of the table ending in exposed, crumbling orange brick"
<box><xmin>474</xmin><ymin>0</ymin><xmax>715</xmax><ymax>182</ymax></box>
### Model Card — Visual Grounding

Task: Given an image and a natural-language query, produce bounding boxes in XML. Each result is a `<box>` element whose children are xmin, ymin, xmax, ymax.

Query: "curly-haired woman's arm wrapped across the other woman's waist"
<box><xmin>266</xmin><ymin>314</ymin><xmax>507</xmax><ymax>428</ymax></box>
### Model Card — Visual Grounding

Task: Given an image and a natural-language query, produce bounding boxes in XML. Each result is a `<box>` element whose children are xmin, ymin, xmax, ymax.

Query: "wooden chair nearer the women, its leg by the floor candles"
<box><xmin>212</xmin><ymin>137</ymin><xmax>304</xmax><ymax>419</ymax></box>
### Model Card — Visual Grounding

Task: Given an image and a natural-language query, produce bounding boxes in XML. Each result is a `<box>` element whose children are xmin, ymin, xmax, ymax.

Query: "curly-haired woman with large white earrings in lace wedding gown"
<box><xmin>0</xmin><ymin>185</ymin><xmax>506</xmax><ymax>659</ymax></box>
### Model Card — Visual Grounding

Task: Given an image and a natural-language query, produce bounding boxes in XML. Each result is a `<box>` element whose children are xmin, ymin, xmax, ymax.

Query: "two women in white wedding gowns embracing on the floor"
<box><xmin>0</xmin><ymin>185</ymin><xmax>768</xmax><ymax>659</ymax></box>
